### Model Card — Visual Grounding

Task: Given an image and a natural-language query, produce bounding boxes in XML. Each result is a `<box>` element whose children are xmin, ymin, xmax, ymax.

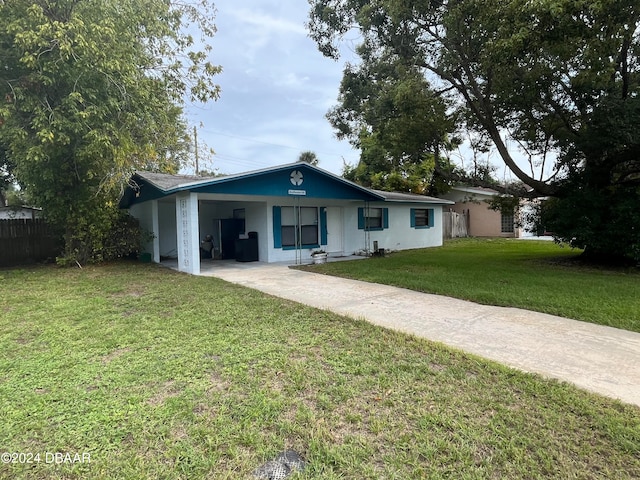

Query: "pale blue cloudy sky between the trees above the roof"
<box><xmin>182</xmin><ymin>0</ymin><xmax>359</xmax><ymax>174</ymax></box>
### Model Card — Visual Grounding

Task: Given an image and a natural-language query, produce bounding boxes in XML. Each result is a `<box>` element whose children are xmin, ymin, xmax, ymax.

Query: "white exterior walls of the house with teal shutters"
<box><xmin>125</xmin><ymin>193</ymin><xmax>442</xmax><ymax>271</ymax></box>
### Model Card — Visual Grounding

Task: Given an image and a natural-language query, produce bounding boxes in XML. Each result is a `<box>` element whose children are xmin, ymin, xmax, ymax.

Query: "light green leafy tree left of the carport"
<box><xmin>0</xmin><ymin>0</ymin><xmax>219</xmax><ymax>261</ymax></box>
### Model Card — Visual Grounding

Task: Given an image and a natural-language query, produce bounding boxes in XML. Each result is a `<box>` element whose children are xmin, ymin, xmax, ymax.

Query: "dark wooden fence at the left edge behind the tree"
<box><xmin>0</xmin><ymin>218</ymin><xmax>59</xmax><ymax>267</ymax></box>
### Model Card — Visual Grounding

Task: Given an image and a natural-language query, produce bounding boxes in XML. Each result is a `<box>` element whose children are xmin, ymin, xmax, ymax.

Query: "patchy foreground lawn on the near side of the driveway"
<box><xmin>0</xmin><ymin>259</ymin><xmax>640</xmax><ymax>479</ymax></box>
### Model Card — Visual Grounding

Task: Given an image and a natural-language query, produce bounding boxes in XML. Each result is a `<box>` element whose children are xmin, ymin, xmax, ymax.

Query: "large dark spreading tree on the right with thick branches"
<box><xmin>309</xmin><ymin>0</ymin><xmax>640</xmax><ymax>259</ymax></box>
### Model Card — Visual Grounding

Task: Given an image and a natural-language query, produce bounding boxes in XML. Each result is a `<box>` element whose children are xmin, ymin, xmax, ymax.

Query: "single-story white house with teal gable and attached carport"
<box><xmin>120</xmin><ymin>162</ymin><xmax>453</xmax><ymax>274</ymax></box>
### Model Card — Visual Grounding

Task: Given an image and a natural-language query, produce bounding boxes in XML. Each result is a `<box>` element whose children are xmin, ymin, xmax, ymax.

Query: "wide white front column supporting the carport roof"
<box><xmin>176</xmin><ymin>193</ymin><xmax>200</xmax><ymax>275</ymax></box>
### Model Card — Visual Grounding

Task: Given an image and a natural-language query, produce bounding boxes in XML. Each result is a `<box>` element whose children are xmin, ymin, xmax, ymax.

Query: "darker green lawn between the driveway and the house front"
<box><xmin>304</xmin><ymin>239</ymin><xmax>640</xmax><ymax>332</ymax></box>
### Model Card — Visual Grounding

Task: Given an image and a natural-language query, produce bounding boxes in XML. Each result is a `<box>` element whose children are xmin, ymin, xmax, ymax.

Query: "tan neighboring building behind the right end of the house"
<box><xmin>442</xmin><ymin>186</ymin><xmax>521</xmax><ymax>237</ymax></box>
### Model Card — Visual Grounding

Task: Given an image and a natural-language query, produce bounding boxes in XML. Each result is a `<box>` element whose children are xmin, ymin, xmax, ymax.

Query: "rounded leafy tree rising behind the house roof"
<box><xmin>327</xmin><ymin>43</ymin><xmax>456</xmax><ymax>194</ymax></box>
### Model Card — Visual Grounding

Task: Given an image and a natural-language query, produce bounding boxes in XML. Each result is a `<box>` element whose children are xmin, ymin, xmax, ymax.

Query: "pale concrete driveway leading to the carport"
<box><xmin>194</xmin><ymin>261</ymin><xmax>640</xmax><ymax>406</ymax></box>
